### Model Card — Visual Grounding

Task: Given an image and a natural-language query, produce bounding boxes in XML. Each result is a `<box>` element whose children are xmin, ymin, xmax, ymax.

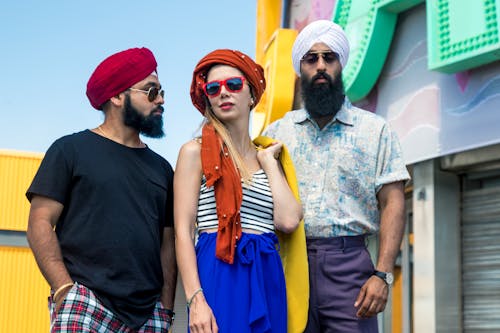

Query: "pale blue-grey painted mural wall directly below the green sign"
<box><xmin>369</xmin><ymin>6</ymin><xmax>500</xmax><ymax>164</ymax></box>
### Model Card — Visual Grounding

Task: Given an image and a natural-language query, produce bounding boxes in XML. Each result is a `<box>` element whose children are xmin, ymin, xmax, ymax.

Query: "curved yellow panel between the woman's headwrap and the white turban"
<box><xmin>252</xmin><ymin>29</ymin><xmax>297</xmax><ymax>137</ymax></box>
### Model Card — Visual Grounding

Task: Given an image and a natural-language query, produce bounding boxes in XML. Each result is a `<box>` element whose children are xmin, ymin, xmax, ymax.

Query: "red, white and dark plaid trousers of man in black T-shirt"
<box><xmin>49</xmin><ymin>282</ymin><xmax>171</xmax><ymax>333</ymax></box>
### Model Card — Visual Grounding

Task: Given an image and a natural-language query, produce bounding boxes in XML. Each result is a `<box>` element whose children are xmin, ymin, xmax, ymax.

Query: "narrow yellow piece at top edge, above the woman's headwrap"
<box><xmin>255</xmin><ymin>0</ymin><xmax>282</xmax><ymax>64</ymax></box>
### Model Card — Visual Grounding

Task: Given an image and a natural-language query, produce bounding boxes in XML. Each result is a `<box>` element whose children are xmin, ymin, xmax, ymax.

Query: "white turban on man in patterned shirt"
<box><xmin>292</xmin><ymin>20</ymin><xmax>349</xmax><ymax>76</ymax></box>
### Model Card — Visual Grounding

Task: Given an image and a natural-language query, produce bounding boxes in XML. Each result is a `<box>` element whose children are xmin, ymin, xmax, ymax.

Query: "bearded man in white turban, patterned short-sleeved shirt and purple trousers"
<box><xmin>264</xmin><ymin>20</ymin><xmax>409</xmax><ymax>333</ymax></box>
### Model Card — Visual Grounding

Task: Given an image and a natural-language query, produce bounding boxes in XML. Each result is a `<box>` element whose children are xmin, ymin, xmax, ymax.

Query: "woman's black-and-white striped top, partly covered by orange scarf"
<box><xmin>197</xmin><ymin>169</ymin><xmax>274</xmax><ymax>233</ymax></box>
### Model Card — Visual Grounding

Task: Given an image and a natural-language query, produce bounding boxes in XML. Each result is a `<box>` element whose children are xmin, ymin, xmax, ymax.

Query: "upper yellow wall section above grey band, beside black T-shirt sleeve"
<box><xmin>0</xmin><ymin>150</ymin><xmax>43</xmax><ymax>231</ymax></box>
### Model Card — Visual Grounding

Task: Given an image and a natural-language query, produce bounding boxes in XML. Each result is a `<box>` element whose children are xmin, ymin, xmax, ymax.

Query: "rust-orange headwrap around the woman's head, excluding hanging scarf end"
<box><xmin>191</xmin><ymin>49</ymin><xmax>266</xmax><ymax>114</ymax></box>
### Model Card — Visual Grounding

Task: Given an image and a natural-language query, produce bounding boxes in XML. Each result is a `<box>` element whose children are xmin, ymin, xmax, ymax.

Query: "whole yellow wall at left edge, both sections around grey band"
<box><xmin>0</xmin><ymin>150</ymin><xmax>49</xmax><ymax>333</ymax></box>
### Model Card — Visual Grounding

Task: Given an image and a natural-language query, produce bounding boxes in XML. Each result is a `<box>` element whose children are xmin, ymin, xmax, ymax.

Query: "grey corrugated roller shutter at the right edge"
<box><xmin>462</xmin><ymin>178</ymin><xmax>500</xmax><ymax>333</ymax></box>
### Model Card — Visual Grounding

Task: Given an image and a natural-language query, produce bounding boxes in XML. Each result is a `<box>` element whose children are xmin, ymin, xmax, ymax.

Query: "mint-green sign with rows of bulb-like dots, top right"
<box><xmin>333</xmin><ymin>0</ymin><xmax>500</xmax><ymax>101</ymax></box>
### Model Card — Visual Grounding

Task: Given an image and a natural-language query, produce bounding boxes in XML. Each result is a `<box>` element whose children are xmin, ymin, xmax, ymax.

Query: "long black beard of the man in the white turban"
<box><xmin>300</xmin><ymin>72</ymin><xmax>345</xmax><ymax>119</ymax></box>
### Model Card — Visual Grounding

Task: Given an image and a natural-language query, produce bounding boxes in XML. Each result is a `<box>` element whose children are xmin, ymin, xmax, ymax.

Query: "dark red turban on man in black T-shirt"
<box><xmin>87</xmin><ymin>47</ymin><xmax>157</xmax><ymax>110</ymax></box>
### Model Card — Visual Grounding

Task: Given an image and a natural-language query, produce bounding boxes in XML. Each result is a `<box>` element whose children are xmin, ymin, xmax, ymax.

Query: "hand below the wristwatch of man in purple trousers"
<box><xmin>354</xmin><ymin>276</ymin><xmax>389</xmax><ymax>318</ymax></box>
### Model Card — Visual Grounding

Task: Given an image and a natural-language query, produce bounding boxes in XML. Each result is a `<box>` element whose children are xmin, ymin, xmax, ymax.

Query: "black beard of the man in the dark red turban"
<box><xmin>123</xmin><ymin>95</ymin><xmax>165</xmax><ymax>138</ymax></box>
